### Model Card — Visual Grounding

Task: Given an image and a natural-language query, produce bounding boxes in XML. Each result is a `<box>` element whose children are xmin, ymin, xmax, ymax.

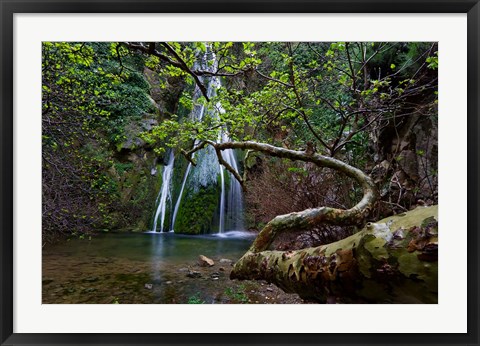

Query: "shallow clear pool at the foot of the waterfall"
<box><xmin>42</xmin><ymin>231</ymin><xmax>255</xmax><ymax>304</ymax></box>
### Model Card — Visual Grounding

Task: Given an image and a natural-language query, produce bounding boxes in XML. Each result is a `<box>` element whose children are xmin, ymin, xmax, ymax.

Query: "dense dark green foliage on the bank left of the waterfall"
<box><xmin>42</xmin><ymin>42</ymin><xmax>151</xmax><ymax>240</ymax></box>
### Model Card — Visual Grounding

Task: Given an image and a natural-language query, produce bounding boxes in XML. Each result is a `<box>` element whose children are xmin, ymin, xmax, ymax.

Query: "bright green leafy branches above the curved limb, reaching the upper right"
<box><xmin>134</xmin><ymin>42</ymin><xmax>438</xmax><ymax>216</ymax></box>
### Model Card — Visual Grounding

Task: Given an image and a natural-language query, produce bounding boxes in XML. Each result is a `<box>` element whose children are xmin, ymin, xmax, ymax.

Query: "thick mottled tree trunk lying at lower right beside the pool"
<box><xmin>230</xmin><ymin>206</ymin><xmax>438</xmax><ymax>303</ymax></box>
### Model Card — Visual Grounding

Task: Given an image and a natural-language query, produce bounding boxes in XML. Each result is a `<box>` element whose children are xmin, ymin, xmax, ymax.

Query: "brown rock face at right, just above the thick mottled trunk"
<box><xmin>370</xmin><ymin>114</ymin><xmax>438</xmax><ymax>215</ymax></box>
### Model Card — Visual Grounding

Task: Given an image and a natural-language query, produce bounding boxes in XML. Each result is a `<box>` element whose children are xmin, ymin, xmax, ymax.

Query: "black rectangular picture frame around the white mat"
<box><xmin>0</xmin><ymin>0</ymin><xmax>480</xmax><ymax>346</ymax></box>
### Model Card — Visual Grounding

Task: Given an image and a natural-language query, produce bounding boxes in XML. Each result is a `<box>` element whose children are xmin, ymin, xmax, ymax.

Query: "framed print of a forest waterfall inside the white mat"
<box><xmin>42</xmin><ymin>42</ymin><xmax>438</xmax><ymax>304</ymax></box>
